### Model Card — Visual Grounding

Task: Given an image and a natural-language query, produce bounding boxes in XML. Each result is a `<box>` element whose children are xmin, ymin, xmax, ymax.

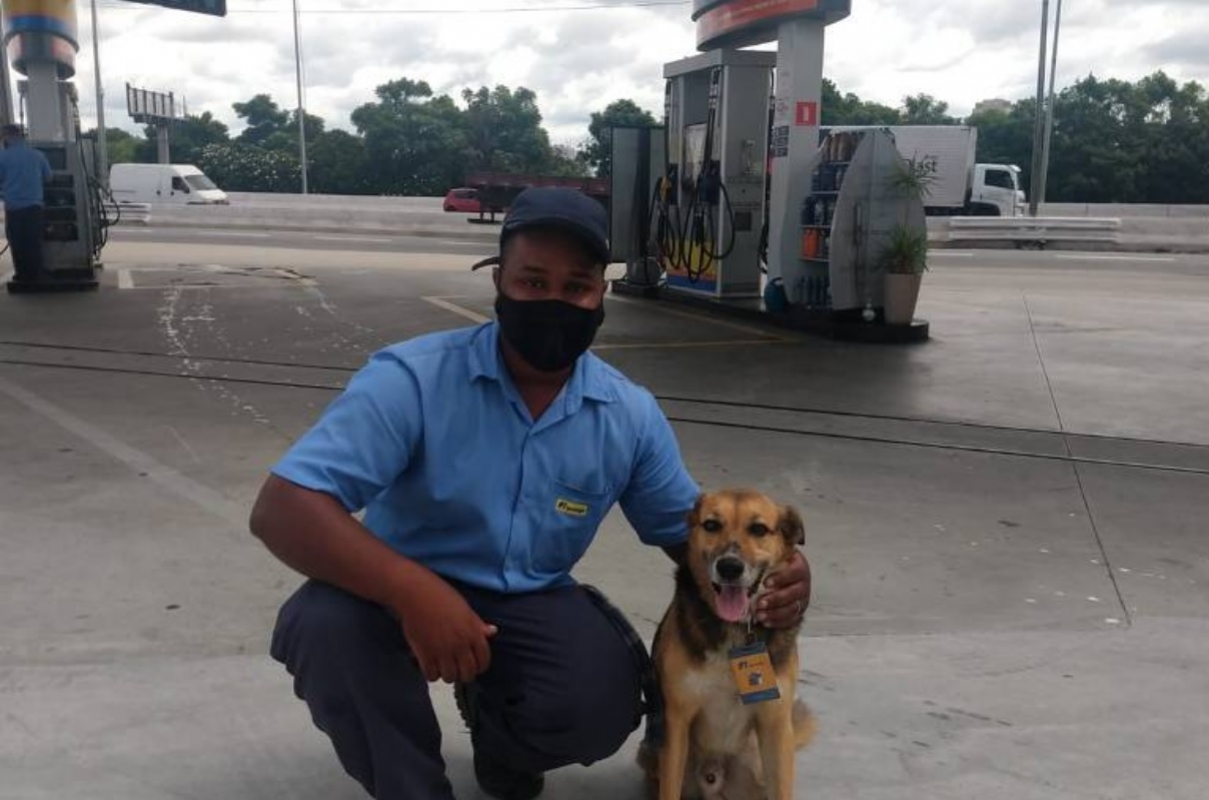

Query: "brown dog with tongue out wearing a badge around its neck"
<box><xmin>638</xmin><ymin>491</ymin><xmax>815</xmax><ymax>800</ymax></box>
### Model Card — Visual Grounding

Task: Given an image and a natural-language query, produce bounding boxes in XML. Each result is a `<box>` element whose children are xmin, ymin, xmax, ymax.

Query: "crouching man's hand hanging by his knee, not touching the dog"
<box><xmin>398</xmin><ymin>575</ymin><xmax>496</xmax><ymax>683</ymax></box>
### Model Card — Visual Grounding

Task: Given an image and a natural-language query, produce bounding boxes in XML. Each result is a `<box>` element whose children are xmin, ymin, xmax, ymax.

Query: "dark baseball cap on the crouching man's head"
<box><xmin>470</xmin><ymin>186</ymin><xmax>612</xmax><ymax>269</ymax></box>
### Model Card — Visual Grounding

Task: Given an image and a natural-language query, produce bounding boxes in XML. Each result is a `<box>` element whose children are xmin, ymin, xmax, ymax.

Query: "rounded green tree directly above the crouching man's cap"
<box><xmin>462</xmin><ymin>86</ymin><xmax>550</xmax><ymax>173</ymax></box>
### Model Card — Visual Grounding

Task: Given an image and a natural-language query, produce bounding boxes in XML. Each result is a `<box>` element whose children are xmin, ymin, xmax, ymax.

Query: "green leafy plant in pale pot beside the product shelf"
<box><xmin>880</xmin><ymin>158</ymin><xmax>937</xmax><ymax>325</ymax></box>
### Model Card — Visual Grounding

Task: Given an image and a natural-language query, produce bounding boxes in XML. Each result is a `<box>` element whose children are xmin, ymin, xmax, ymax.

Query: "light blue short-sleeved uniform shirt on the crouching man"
<box><xmin>272</xmin><ymin>323</ymin><xmax>700</xmax><ymax>592</ymax></box>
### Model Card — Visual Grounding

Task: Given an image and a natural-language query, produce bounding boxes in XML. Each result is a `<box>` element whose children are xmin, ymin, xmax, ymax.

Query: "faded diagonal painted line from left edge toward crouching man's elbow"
<box><xmin>0</xmin><ymin>378</ymin><xmax>248</xmax><ymax>531</ymax></box>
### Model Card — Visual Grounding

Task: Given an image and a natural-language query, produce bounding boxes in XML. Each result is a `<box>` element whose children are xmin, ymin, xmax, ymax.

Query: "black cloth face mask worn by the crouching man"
<box><xmin>496</xmin><ymin>291</ymin><xmax>605</xmax><ymax>372</ymax></box>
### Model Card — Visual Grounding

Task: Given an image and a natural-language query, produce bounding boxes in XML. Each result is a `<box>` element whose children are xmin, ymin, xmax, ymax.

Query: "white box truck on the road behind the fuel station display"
<box><xmin>820</xmin><ymin>124</ymin><xmax>1028</xmax><ymax>216</ymax></box>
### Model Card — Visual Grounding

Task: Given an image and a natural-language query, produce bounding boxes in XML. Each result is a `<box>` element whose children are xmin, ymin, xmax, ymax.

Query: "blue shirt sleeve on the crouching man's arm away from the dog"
<box><xmin>271</xmin><ymin>353</ymin><xmax>423</xmax><ymax>512</ymax></box>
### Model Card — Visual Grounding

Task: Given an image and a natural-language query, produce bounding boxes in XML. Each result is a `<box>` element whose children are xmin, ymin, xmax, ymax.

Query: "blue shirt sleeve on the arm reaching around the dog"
<box><xmin>619</xmin><ymin>395</ymin><xmax>701</xmax><ymax>547</ymax></box>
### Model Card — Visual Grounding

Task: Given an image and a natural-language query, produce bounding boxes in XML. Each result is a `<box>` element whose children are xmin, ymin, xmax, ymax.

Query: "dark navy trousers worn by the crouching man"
<box><xmin>271</xmin><ymin>580</ymin><xmax>643</xmax><ymax>800</ymax></box>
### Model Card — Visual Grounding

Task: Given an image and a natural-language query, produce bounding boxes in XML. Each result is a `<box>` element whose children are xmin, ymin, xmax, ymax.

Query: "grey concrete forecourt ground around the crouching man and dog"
<box><xmin>0</xmin><ymin>239</ymin><xmax>1209</xmax><ymax>800</ymax></box>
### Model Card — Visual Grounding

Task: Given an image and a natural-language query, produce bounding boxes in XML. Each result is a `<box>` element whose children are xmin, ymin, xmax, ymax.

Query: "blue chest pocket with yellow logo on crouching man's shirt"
<box><xmin>532</xmin><ymin>480</ymin><xmax>611</xmax><ymax>574</ymax></box>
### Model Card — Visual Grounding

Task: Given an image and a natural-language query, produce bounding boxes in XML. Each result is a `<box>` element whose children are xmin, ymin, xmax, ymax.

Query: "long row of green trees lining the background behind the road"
<box><xmin>91</xmin><ymin>73</ymin><xmax>1209</xmax><ymax>204</ymax></box>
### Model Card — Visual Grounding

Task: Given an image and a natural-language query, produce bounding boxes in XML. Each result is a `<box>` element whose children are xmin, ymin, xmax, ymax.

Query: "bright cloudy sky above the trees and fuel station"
<box><xmin>54</xmin><ymin>0</ymin><xmax>1209</xmax><ymax>144</ymax></box>
